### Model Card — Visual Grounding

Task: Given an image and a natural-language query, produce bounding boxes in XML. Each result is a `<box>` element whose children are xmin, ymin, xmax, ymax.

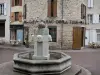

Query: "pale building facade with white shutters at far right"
<box><xmin>85</xmin><ymin>0</ymin><xmax>100</xmax><ymax>45</ymax></box>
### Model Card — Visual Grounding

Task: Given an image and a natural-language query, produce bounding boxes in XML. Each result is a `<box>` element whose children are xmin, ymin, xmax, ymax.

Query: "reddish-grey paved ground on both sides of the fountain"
<box><xmin>0</xmin><ymin>46</ymin><xmax>100</xmax><ymax>75</ymax></box>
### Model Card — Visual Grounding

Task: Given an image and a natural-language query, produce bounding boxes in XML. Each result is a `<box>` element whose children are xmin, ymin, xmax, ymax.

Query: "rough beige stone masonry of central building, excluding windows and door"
<box><xmin>25</xmin><ymin>0</ymin><xmax>86</xmax><ymax>49</ymax></box>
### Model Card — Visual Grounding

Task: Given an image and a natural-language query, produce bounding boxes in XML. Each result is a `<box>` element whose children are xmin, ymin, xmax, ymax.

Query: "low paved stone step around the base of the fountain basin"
<box><xmin>0</xmin><ymin>62</ymin><xmax>91</xmax><ymax>75</ymax></box>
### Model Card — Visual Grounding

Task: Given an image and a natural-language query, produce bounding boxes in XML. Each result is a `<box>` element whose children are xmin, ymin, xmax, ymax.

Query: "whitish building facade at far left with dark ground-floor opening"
<box><xmin>0</xmin><ymin>0</ymin><xmax>10</xmax><ymax>43</ymax></box>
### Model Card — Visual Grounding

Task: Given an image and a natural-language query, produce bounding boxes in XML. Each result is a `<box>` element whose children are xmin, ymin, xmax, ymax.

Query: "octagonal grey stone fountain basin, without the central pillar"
<box><xmin>13</xmin><ymin>51</ymin><xmax>71</xmax><ymax>74</ymax></box>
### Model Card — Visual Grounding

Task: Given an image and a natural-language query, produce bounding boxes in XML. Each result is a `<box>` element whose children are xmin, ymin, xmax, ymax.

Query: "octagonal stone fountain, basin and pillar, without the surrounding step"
<box><xmin>14</xmin><ymin>24</ymin><xmax>71</xmax><ymax>74</ymax></box>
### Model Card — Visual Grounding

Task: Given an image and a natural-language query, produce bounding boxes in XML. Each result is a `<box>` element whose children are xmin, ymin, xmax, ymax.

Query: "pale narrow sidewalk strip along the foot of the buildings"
<box><xmin>0</xmin><ymin>45</ymin><xmax>100</xmax><ymax>52</ymax></box>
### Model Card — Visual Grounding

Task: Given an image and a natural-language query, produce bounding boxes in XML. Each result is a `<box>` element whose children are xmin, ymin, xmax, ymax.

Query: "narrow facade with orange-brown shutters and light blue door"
<box><xmin>10</xmin><ymin>0</ymin><xmax>24</xmax><ymax>42</ymax></box>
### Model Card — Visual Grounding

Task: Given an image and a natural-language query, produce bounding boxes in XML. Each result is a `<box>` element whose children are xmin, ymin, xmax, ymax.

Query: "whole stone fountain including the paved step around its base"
<box><xmin>0</xmin><ymin>24</ymin><xmax>91</xmax><ymax>75</ymax></box>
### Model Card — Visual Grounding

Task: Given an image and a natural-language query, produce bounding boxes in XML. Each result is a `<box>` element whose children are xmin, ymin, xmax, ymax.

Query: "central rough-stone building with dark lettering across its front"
<box><xmin>24</xmin><ymin>0</ymin><xmax>87</xmax><ymax>49</ymax></box>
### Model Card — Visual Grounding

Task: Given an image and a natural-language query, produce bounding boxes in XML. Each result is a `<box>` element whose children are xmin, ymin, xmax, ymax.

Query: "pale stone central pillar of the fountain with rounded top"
<box><xmin>32</xmin><ymin>24</ymin><xmax>52</xmax><ymax>60</ymax></box>
